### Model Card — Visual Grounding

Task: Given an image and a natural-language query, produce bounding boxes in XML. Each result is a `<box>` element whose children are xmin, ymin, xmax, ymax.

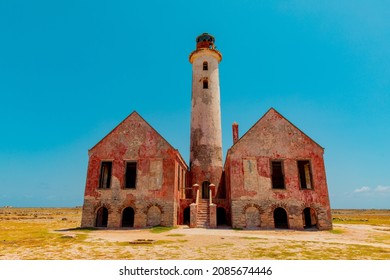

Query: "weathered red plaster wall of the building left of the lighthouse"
<box><xmin>81</xmin><ymin>112</ymin><xmax>187</xmax><ymax>228</ymax></box>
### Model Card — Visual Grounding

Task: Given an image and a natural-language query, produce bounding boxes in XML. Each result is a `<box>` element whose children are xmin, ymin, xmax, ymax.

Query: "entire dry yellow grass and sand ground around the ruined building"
<box><xmin>0</xmin><ymin>208</ymin><xmax>390</xmax><ymax>260</ymax></box>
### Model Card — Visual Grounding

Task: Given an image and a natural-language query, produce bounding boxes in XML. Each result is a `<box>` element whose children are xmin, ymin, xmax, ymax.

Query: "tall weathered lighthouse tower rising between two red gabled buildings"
<box><xmin>189</xmin><ymin>33</ymin><xmax>222</xmax><ymax>199</ymax></box>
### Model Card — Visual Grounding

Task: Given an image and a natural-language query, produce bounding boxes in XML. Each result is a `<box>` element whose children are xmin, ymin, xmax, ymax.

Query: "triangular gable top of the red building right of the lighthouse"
<box><xmin>228</xmin><ymin>108</ymin><xmax>324</xmax><ymax>157</ymax></box>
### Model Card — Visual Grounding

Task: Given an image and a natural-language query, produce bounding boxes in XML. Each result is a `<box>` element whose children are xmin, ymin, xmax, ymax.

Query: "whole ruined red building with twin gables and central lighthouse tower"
<box><xmin>81</xmin><ymin>33</ymin><xmax>332</xmax><ymax>230</ymax></box>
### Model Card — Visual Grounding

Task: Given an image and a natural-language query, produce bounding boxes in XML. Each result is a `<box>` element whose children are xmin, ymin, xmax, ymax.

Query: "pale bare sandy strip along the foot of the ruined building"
<box><xmin>85</xmin><ymin>224</ymin><xmax>390</xmax><ymax>248</ymax></box>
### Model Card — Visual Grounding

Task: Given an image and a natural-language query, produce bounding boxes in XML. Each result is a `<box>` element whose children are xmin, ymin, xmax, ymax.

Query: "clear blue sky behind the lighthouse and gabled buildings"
<box><xmin>0</xmin><ymin>0</ymin><xmax>390</xmax><ymax>208</ymax></box>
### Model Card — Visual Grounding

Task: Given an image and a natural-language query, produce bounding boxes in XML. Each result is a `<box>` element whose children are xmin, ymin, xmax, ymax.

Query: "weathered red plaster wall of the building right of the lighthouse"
<box><xmin>225</xmin><ymin>109</ymin><xmax>332</xmax><ymax>229</ymax></box>
